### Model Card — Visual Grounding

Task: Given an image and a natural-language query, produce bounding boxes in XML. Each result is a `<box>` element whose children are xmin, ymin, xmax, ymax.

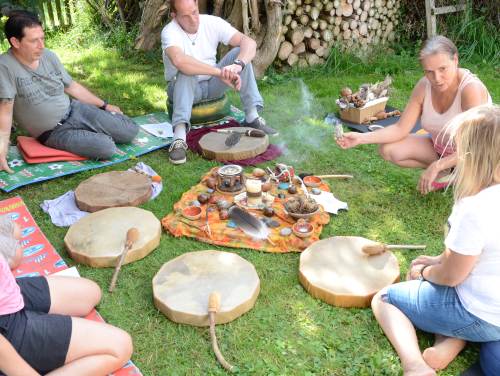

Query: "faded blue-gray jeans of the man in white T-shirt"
<box><xmin>167</xmin><ymin>47</ymin><xmax>264</xmax><ymax>127</ymax></box>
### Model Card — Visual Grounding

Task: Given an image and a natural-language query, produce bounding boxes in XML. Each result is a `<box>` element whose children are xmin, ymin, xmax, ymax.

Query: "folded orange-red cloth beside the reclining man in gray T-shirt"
<box><xmin>17</xmin><ymin>136</ymin><xmax>87</xmax><ymax>163</ymax></box>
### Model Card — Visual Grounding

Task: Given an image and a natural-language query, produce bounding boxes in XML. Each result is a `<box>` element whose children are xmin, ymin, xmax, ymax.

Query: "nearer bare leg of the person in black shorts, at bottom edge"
<box><xmin>48</xmin><ymin>317</ymin><xmax>133</xmax><ymax>376</ymax></box>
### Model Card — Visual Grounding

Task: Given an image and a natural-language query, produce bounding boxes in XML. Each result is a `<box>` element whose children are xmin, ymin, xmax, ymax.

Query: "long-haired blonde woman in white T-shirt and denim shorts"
<box><xmin>372</xmin><ymin>105</ymin><xmax>500</xmax><ymax>375</ymax></box>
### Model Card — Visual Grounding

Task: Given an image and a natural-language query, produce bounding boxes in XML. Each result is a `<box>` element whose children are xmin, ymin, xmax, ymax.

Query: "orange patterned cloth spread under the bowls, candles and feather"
<box><xmin>162</xmin><ymin>168</ymin><xmax>330</xmax><ymax>253</ymax></box>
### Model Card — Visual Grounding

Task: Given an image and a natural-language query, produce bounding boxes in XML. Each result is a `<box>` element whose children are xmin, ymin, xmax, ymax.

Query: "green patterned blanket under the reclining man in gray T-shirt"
<box><xmin>0</xmin><ymin>107</ymin><xmax>243</xmax><ymax>192</ymax></box>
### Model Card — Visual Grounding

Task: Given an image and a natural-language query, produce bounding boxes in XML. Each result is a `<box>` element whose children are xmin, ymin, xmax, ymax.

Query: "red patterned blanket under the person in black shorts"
<box><xmin>0</xmin><ymin>197</ymin><xmax>142</xmax><ymax>376</ymax></box>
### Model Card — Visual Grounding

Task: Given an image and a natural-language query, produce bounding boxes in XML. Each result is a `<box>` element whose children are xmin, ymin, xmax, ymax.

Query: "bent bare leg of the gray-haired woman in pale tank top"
<box><xmin>379</xmin><ymin>134</ymin><xmax>439</xmax><ymax>168</ymax></box>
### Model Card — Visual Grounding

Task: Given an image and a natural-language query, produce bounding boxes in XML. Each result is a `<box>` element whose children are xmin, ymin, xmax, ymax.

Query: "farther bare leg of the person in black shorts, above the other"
<box><xmin>47</xmin><ymin>276</ymin><xmax>101</xmax><ymax>316</ymax></box>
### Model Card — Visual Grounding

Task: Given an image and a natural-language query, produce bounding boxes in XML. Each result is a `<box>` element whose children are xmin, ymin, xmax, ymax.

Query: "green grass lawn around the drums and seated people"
<box><xmin>2</xmin><ymin>36</ymin><xmax>500</xmax><ymax>375</ymax></box>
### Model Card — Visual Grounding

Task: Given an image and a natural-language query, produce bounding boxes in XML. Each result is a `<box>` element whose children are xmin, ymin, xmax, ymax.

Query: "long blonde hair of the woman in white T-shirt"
<box><xmin>447</xmin><ymin>104</ymin><xmax>500</xmax><ymax>201</ymax></box>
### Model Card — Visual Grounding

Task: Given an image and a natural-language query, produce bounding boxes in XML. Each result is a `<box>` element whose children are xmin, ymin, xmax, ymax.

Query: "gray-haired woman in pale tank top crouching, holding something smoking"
<box><xmin>337</xmin><ymin>35</ymin><xmax>491</xmax><ymax>194</ymax></box>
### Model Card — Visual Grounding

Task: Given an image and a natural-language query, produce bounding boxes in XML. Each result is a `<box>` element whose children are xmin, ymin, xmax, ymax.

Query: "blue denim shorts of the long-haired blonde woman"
<box><xmin>382</xmin><ymin>280</ymin><xmax>500</xmax><ymax>342</ymax></box>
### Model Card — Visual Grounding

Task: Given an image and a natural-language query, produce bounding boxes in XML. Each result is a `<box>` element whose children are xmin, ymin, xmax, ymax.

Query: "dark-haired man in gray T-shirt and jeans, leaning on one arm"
<box><xmin>0</xmin><ymin>11</ymin><xmax>138</xmax><ymax>172</ymax></box>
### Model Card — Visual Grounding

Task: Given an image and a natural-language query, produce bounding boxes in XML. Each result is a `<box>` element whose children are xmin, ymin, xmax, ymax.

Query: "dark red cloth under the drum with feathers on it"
<box><xmin>186</xmin><ymin>119</ymin><xmax>283</xmax><ymax>166</ymax></box>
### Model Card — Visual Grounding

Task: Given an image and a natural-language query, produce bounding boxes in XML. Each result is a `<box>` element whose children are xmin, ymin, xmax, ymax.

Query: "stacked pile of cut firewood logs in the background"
<box><xmin>278</xmin><ymin>0</ymin><xmax>400</xmax><ymax>67</ymax></box>
